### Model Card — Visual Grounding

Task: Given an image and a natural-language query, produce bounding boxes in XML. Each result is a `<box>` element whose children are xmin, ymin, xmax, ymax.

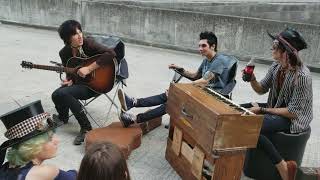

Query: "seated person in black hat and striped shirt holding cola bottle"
<box><xmin>242</xmin><ymin>28</ymin><xmax>313</xmax><ymax>180</ymax></box>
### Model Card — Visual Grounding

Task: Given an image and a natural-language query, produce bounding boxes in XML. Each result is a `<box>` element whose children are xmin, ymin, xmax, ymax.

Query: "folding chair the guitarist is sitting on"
<box><xmin>80</xmin><ymin>35</ymin><xmax>129</xmax><ymax>127</ymax></box>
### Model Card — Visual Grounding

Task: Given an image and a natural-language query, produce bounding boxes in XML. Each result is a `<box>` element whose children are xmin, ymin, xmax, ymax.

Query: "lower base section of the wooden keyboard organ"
<box><xmin>165</xmin><ymin>126</ymin><xmax>245</xmax><ymax>180</ymax></box>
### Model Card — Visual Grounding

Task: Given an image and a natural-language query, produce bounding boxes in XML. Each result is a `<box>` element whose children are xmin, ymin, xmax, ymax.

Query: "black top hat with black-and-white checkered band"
<box><xmin>0</xmin><ymin>100</ymin><xmax>62</xmax><ymax>165</ymax></box>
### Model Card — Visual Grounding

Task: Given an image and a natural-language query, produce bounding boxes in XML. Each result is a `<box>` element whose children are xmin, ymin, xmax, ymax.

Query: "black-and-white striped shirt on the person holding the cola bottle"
<box><xmin>260</xmin><ymin>62</ymin><xmax>313</xmax><ymax>133</ymax></box>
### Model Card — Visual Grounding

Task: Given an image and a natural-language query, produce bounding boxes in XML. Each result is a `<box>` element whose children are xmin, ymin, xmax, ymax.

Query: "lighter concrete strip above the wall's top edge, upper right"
<box><xmin>104</xmin><ymin>0</ymin><xmax>320</xmax><ymax>25</ymax></box>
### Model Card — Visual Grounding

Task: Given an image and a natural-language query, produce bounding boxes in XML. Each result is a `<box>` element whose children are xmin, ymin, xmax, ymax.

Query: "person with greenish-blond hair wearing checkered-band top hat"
<box><xmin>0</xmin><ymin>101</ymin><xmax>77</xmax><ymax>180</ymax></box>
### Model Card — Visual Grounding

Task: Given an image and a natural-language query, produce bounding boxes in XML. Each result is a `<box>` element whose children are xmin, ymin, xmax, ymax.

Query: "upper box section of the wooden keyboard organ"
<box><xmin>167</xmin><ymin>84</ymin><xmax>263</xmax><ymax>152</ymax></box>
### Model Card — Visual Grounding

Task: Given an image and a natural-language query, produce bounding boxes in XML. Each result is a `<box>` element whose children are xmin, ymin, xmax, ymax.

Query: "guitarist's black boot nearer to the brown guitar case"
<box><xmin>73</xmin><ymin>111</ymin><xmax>92</xmax><ymax>145</ymax></box>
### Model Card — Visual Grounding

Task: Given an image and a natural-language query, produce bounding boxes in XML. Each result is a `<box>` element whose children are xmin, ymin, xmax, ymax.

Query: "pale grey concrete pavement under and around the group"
<box><xmin>0</xmin><ymin>24</ymin><xmax>320</xmax><ymax>179</ymax></box>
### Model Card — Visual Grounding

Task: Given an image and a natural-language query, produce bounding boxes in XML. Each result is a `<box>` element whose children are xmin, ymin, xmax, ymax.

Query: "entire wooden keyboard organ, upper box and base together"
<box><xmin>166</xmin><ymin>84</ymin><xmax>263</xmax><ymax>180</ymax></box>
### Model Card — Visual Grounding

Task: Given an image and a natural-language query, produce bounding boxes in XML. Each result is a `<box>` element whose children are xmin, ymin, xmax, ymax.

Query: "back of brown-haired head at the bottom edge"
<box><xmin>77</xmin><ymin>142</ymin><xmax>130</xmax><ymax>180</ymax></box>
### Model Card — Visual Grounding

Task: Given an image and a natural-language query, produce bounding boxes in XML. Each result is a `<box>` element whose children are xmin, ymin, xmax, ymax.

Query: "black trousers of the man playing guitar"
<box><xmin>51</xmin><ymin>84</ymin><xmax>97</xmax><ymax>130</ymax></box>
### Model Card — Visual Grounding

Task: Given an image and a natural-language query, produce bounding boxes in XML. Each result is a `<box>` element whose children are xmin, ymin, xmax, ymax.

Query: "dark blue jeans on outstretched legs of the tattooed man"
<box><xmin>134</xmin><ymin>93</ymin><xmax>167</xmax><ymax>123</ymax></box>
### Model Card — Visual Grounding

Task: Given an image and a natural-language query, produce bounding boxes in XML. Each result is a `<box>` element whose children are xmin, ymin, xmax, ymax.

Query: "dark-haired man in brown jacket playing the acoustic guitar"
<box><xmin>52</xmin><ymin>20</ymin><xmax>116</xmax><ymax>145</ymax></box>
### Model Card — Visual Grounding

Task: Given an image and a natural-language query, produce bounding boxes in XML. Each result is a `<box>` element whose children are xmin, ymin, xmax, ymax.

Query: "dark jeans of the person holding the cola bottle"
<box><xmin>241</xmin><ymin>103</ymin><xmax>291</xmax><ymax>164</ymax></box>
